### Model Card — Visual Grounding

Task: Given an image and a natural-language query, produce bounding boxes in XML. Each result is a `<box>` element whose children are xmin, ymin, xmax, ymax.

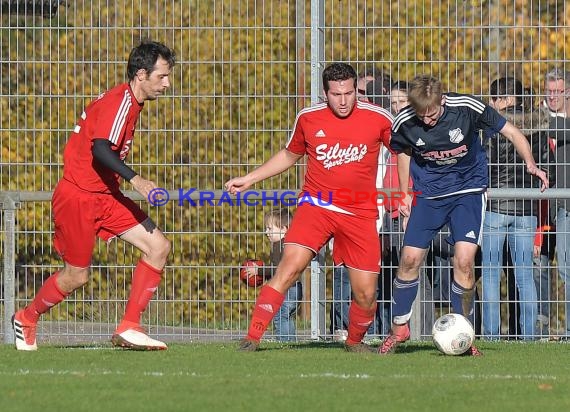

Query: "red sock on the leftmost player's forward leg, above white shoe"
<box><xmin>123</xmin><ymin>259</ymin><xmax>162</xmax><ymax>325</ymax></box>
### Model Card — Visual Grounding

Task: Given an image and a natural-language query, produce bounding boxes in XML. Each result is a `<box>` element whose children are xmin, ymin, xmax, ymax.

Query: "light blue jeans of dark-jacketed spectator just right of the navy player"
<box><xmin>481</xmin><ymin>212</ymin><xmax>538</xmax><ymax>339</ymax></box>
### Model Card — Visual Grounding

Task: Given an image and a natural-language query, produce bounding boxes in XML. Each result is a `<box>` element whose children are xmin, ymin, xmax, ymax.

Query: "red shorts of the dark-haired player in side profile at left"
<box><xmin>51</xmin><ymin>179</ymin><xmax>148</xmax><ymax>267</ymax></box>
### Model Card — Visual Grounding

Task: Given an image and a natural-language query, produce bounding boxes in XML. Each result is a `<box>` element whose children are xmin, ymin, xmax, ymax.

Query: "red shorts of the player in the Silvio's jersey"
<box><xmin>284</xmin><ymin>203</ymin><xmax>380</xmax><ymax>273</ymax></box>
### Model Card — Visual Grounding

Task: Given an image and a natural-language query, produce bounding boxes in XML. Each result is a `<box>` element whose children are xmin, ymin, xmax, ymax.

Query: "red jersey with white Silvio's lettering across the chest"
<box><xmin>285</xmin><ymin>101</ymin><xmax>392</xmax><ymax>218</ymax></box>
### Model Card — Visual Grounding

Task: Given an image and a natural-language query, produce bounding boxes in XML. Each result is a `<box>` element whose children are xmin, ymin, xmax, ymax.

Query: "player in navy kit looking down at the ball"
<box><xmin>378</xmin><ymin>75</ymin><xmax>548</xmax><ymax>356</ymax></box>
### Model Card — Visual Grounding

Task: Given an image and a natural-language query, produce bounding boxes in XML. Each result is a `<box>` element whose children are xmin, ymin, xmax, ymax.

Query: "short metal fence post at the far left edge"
<box><xmin>0</xmin><ymin>193</ymin><xmax>20</xmax><ymax>343</ymax></box>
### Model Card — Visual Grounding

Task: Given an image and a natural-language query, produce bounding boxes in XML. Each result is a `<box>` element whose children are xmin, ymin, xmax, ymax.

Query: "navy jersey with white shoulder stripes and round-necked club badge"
<box><xmin>390</xmin><ymin>93</ymin><xmax>506</xmax><ymax>198</ymax></box>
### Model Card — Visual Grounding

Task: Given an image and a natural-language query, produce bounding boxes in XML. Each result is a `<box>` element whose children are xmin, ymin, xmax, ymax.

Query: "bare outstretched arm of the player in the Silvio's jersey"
<box><xmin>224</xmin><ymin>149</ymin><xmax>303</xmax><ymax>194</ymax></box>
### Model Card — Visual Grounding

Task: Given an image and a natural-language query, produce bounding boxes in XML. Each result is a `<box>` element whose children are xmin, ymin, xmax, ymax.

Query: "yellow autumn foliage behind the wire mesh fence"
<box><xmin>0</xmin><ymin>0</ymin><xmax>570</xmax><ymax>324</ymax></box>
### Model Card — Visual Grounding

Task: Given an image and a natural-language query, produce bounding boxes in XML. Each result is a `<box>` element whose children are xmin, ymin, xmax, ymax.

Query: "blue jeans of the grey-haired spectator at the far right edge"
<box><xmin>556</xmin><ymin>209</ymin><xmax>570</xmax><ymax>337</ymax></box>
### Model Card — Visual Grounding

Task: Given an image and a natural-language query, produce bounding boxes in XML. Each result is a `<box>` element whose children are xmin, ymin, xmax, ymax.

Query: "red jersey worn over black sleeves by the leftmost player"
<box><xmin>63</xmin><ymin>83</ymin><xmax>143</xmax><ymax>193</ymax></box>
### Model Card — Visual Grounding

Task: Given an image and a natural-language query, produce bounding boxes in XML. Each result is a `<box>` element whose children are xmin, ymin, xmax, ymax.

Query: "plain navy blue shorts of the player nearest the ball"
<box><xmin>404</xmin><ymin>193</ymin><xmax>487</xmax><ymax>249</ymax></box>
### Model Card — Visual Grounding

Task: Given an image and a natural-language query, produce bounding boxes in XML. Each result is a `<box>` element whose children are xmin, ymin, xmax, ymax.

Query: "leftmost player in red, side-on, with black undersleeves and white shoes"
<box><xmin>12</xmin><ymin>41</ymin><xmax>175</xmax><ymax>351</ymax></box>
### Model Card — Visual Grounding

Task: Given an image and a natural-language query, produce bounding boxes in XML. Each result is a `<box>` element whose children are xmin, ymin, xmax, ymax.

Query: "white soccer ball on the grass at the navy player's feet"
<box><xmin>431</xmin><ymin>313</ymin><xmax>475</xmax><ymax>355</ymax></box>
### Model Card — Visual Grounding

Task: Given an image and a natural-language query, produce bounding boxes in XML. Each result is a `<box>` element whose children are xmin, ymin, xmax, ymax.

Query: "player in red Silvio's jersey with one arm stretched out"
<box><xmin>225</xmin><ymin>63</ymin><xmax>392</xmax><ymax>352</ymax></box>
